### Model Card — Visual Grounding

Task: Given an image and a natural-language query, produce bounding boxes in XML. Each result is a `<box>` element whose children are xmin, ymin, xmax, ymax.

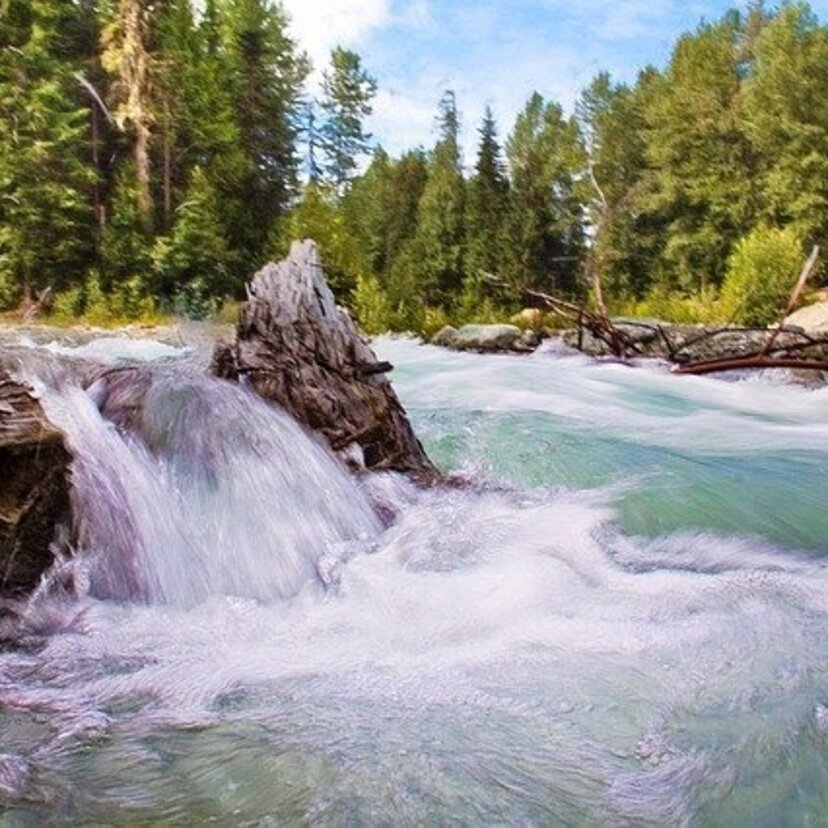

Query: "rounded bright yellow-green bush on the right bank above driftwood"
<box><xmin>721</xmin><ymin>226</ymin><xmax>803</xmax><ymax>326</ymax></box>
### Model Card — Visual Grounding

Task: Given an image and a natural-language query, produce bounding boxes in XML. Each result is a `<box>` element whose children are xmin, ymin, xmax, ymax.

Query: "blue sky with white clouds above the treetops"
<box><xmin>282</xmin><ymin>0</ymin><xmax>828</xmax><ymax>160</ymax></box>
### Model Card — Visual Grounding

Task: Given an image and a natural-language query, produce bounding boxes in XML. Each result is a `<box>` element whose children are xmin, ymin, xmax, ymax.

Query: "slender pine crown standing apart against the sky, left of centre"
<box><xmin>320</xmin><ymin>46</ymin><xmax>377</xmax><ymax>188</ymax></box>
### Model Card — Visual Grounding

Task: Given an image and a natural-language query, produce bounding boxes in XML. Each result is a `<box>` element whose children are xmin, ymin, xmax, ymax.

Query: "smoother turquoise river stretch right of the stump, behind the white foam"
<box><xmin>384</xmin><ymin>342</ymin><xmax>828</xmax><ymax>555</ymax></box>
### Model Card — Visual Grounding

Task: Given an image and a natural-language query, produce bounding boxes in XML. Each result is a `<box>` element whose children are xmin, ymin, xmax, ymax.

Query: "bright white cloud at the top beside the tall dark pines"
<box><xmin>282</xmin><ymin>0</ymin><xmax>391</xmax><ymax>72</ymax></box>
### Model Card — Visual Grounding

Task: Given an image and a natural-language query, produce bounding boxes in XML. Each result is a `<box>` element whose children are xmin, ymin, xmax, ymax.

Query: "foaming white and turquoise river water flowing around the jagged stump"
<box><xmin>0</xmin><ymin>340</ymin><xmax>828</xmax><ymax>826</ymax></box>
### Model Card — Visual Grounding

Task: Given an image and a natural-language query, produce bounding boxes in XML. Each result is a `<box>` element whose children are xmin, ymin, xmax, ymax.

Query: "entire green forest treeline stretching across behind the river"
<box><xmin>0</xmin><ymin>0</ymin><xmax>828</xmax><ymax>331</ymax></box>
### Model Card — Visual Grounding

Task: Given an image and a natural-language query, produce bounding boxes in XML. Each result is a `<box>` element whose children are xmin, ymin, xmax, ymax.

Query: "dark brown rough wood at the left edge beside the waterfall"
<box><xmin>0</xmin><ymin>370</ymin><xmax>71</xmax><ymax>596</ymax></box>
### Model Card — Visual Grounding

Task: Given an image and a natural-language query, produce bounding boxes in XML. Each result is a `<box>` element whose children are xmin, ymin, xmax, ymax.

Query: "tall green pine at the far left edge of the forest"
<box><xmin>0</xmin><ymin>0</ymin><xmax>95</xmax><ymax>302</ymax></box>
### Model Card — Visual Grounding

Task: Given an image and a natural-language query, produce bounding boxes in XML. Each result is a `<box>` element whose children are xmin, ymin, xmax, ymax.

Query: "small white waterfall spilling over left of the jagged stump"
<box><xmin>34</xmin><ymin>368</ymin><xmax>379</xmax><ymax>607</ymax></box>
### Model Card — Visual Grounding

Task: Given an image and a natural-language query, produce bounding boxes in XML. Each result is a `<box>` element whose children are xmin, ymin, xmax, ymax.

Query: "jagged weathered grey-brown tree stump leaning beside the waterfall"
<box><xmin>212</xmin><ymin>241</ymin><xmax>437</xmax><ymax>479</ymax></box>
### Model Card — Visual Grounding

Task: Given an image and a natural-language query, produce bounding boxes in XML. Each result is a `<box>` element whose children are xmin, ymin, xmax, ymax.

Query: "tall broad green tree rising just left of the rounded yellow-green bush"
<box><xmin>639</xmin><ymin>13</ymin><xmax>755</xmax><ymax>291</ymax></box>
